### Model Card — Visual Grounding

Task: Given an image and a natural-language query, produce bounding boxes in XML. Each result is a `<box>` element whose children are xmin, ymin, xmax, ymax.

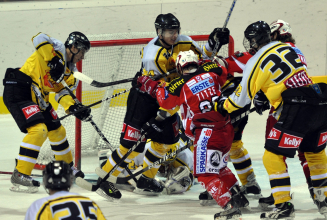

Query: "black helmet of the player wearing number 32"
<box><xmin>243</xmin><ymin>21</ymin><xmax>271</xmax><ymax>55</ymax></box>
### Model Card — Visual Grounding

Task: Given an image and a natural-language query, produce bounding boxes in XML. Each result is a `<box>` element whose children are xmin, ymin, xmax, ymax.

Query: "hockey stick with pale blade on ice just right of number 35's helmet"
<box><xmin>76</xmin><ymin>132</ymin><xmax>146</xmax><ymax>192</ymax></box>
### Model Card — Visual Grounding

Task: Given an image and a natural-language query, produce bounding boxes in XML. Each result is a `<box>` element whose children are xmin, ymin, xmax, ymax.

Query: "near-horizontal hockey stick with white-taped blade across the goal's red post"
<box><xmin>73</xmin><ymin>69</ymin><xmax>176</xmax><ymax>88</ymax></box>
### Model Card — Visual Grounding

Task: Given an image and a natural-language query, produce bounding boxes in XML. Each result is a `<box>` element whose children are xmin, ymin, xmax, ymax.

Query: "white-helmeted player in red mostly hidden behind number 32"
<box><xmin>257</xmin><ymin>19</ymin><xmax>314</xmax><ymax>209</ymax></box>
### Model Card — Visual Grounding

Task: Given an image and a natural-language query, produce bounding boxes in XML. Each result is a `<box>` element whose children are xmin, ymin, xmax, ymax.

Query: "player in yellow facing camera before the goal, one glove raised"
<box><xmin>100</xmin><ymin>13</ymin><xmax>233</xmax><ymax>199</ymax></box>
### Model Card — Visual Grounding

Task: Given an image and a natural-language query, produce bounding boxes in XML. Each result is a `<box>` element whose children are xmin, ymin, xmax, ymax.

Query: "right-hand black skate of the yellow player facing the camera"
<box><xmin>134</xmin><ymin>175</ymin><xmax>164</xmax><ymax>196</ymax></box>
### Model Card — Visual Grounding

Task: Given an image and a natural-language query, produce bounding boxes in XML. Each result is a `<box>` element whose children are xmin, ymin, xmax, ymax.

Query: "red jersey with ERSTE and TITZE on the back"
<box><xmin>156</xmin><ymin>62</ymin><xmax>227</xmax><ymax>139</ymax></box>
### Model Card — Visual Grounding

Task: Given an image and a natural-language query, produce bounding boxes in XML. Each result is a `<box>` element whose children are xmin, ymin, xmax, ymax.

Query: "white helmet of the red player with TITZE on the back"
<box><xmin>175</xmin><ymin>50</ymin><xmax>199</xmax><ymax>75</ymax></box>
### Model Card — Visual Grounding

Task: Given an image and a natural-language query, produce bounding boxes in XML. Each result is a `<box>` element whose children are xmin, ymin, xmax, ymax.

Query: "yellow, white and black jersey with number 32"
<box><xmin>224</xmin><ymin>41</ymin><xmax>312</xmax><ymax>113</ymax></box>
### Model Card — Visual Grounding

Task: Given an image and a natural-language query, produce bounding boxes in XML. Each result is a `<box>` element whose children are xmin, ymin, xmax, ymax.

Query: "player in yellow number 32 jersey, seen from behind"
<box><xmin>215</xmin><ymin>21</ymin><xmax>327</xmax><ymax>219</ymax></box>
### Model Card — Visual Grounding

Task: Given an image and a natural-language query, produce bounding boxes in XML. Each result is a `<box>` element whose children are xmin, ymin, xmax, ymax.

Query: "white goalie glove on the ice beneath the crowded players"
<box><xmin>165</xmin><ymin>166</ymin><xmax>193</xmax><ymax>194</ymax></box>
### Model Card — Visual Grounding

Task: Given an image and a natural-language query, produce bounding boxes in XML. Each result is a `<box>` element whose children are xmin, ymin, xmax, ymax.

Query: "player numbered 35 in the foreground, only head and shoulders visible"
<box><xmin>25</xmin><ymin>161</ymin><xmax>106</xmax><ymax>220</ymax></box>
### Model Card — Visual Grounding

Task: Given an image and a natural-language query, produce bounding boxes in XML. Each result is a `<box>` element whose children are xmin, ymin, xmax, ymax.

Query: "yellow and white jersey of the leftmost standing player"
<box><xmin>20</xmin><ymin>33</ymin><xmax>78</xmax><ymax>110</ymax></box>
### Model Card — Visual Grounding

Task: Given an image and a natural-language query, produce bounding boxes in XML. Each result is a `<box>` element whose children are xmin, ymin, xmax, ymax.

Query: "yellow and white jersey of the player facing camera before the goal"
<box><xmin>141</xmin><ymin>35</ymin><xmax>211</xmax><ymax>82</ymax></box>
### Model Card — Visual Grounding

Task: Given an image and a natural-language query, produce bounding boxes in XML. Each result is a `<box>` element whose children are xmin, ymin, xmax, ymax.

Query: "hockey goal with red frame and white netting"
<box><xmin>37</xmin><ymin>32</ymin><xmax>234</xmax><ymax>168</ymax></box>
